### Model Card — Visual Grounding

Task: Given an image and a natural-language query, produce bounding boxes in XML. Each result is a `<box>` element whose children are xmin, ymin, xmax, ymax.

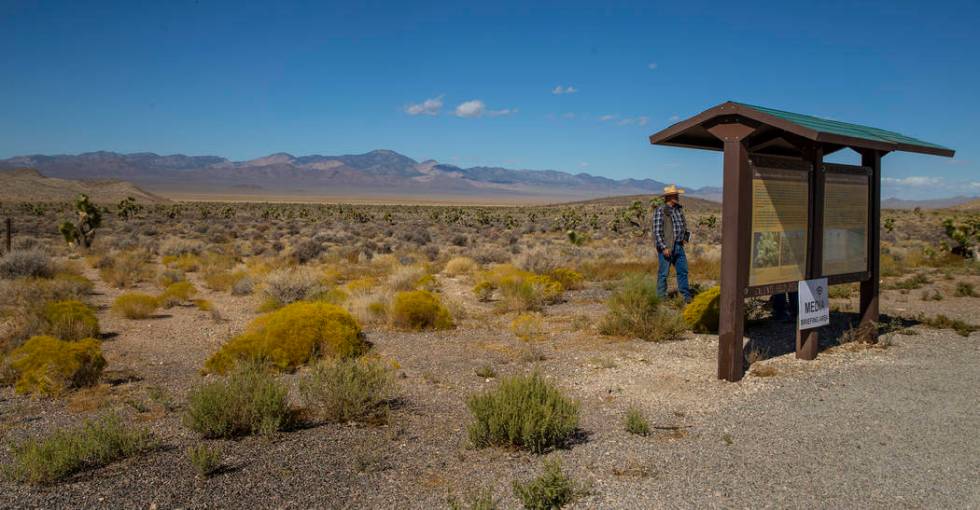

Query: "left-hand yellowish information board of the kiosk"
<box><xmin>749</xmin><ymin>158</ymin><xmax>810</xmax><ymax>286</ymax></box>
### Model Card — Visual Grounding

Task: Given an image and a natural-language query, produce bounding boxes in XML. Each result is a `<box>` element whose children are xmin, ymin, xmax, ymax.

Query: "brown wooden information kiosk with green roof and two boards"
<box><xmin>650</xmin><ymin>102</ymin><xmax>954</xmax><ymax>381</ymax></box>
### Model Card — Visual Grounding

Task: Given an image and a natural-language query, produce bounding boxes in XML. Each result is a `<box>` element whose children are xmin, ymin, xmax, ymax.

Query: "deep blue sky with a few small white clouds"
<box><xmin>0</xmin><ymin>0</ymin><xmax>980</xmax><ymax>198</ymax></box>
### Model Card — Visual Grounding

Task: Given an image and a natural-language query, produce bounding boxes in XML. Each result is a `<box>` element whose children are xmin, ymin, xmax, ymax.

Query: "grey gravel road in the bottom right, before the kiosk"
<box><xmin>580</xmin><ymin>330</ymin><xmax>980</xmax><ymax>508</ymax></box>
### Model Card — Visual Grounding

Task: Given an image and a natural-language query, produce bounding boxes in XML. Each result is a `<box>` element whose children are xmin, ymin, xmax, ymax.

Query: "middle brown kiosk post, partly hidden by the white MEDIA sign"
<box><xmin>796</xmin><ymin>144</ymin><xmax>827</xmax><ymax>360</ymax></box>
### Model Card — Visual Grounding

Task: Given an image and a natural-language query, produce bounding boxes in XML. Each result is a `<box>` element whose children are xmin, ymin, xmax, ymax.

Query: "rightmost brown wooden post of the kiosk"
<box><xmin>858</xmin><ymin>150</ymin><xmax>884</xmax><ymax>339</ymax></box>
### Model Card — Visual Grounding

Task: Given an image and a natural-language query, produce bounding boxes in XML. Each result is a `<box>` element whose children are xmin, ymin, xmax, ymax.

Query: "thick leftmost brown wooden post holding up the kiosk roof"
<box><xmin>708</xmin><ymin>122</ymin><xmax>755</xmax><ymax>382</ymax></box>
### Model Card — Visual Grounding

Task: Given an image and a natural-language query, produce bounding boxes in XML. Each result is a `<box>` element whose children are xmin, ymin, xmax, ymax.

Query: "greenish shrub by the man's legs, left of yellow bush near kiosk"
<box><xmin>599</xmin><ymin>273</ymin><xmax>687</xmax><ymax>342</ymax></box>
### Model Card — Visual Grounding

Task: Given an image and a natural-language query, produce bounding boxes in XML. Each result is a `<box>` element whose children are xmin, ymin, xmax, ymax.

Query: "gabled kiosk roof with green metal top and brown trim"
<box><xmin>650</xmin><ymin>101</ymin><xmax>955</xmax><ymax>157</ymax></box>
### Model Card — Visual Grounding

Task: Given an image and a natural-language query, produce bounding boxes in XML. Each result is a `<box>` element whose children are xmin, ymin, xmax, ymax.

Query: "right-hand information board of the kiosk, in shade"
<box><xmin>822</xmin><ymin>169</ymin><xmax>869</xmax><ymax>276</ymax></box>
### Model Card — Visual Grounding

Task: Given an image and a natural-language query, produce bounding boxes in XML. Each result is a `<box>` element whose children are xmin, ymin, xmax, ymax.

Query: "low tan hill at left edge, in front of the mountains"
<box><xmin>0</xmin><ymin>168</ymin><xmax>169</xmax><ymax>203</ymax></box>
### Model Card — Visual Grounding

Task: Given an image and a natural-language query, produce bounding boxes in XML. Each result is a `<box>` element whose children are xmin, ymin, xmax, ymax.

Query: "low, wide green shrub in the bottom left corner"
<box><xmin>6</xmin><ymin>415</ymin><xmax>157</xmax><ymax>483</ymax></box>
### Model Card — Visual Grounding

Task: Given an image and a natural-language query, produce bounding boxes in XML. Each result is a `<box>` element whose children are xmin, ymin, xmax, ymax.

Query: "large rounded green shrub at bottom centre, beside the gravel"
<box><xmin>467</xmin><ymin>373</ymin><xmax>578</xmax><ymax>453</ymax></box>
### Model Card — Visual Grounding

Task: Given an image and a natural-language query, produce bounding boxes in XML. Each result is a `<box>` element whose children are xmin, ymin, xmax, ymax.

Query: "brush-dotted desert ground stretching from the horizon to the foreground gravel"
<box><xmin>0</xmin><ymin>198</ymin><xmax>980</xmax><ymax>508</ymax></box>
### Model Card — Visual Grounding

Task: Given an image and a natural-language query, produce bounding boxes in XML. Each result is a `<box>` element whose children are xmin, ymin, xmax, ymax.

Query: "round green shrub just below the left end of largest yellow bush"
<box><xmin>184</xmin><ymin>364</ymin><xmax>291</xmax><ymax>438</ymax></box>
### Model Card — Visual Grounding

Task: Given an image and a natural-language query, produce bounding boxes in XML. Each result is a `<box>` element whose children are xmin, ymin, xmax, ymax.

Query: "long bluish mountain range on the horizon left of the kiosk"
<box><xmin>0</xmin><ymin>150</ymin><xmax>680</xmax><ymax>201</ymax></box>
